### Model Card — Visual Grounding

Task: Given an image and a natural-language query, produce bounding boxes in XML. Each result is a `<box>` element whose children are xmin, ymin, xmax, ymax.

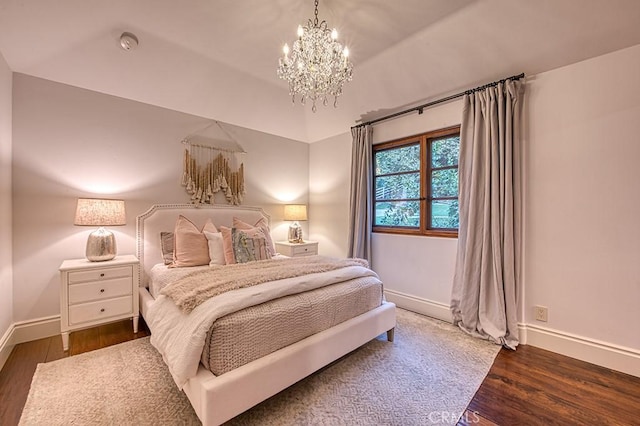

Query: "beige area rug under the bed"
<box><xmin>20</xmin><ymin>309</ymin><xmax>500</xmax><ymax>426</ymax></box>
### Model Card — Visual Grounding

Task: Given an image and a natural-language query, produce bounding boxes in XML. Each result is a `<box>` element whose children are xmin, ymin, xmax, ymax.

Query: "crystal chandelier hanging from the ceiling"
<box><xmin>278</xmin><ymin>0</ymin><xmax>353</xmax><ymax>112</ymax></box>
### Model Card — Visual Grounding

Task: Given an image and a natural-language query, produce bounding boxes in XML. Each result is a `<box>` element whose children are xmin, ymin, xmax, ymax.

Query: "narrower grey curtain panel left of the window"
<box><xmin>348</xmin><ymin>125</ymin><xmax>373</xmax><ymax>262</ymax></box>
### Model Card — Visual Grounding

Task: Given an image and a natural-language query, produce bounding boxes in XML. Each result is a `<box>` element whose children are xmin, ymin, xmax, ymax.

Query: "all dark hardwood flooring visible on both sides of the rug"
<box><xmin>0</xmin><ymin>319</ymin><xmax>640</xmax><ymax>426</ymax></box>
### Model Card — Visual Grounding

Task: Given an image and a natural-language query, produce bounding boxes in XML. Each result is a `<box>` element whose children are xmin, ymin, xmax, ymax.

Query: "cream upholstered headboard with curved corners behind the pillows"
<box><xmin>136</xmin><ymin>204</ymin><xmax>271</xmax><ymax>287</ymax></box>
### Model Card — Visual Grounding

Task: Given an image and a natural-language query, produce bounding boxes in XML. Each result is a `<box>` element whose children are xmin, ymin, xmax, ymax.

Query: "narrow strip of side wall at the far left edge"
<box><xmin>0</xmin><ymin>53</ymin><xmax>13</xmax><ymax>344</ymax></box>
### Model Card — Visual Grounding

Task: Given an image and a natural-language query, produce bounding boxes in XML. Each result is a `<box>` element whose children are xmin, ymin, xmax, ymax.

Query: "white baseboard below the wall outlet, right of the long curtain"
<box><xmin>521</xmin><ymin>324</ymin><xmax>640</xmax><ymax>377</ymax></box>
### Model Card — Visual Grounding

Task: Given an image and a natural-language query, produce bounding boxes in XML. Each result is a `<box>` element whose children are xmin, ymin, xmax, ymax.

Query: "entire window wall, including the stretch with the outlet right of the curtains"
<box><xmin>310</xmin><ymin>45</ymin><xmax>640</xmax><ymax>376</ymax></box>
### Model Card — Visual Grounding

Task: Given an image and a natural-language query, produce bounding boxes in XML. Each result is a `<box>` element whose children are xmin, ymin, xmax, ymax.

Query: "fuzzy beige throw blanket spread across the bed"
<box><xmin>161</xmin><ymin>256</ymin><xmax>369</xmax><ymax>313</ymax></box>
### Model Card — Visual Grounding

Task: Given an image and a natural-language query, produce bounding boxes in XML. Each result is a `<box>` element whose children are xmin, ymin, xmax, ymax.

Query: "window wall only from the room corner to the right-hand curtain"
<box><xmin>309</xmin><ymin>101</ymin><xmax>461</xmax><ymax>320</ymax></box>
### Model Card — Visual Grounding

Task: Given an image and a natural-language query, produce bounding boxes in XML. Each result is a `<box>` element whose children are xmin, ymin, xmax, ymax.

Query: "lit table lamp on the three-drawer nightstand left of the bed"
<box><xmin>73</xmin><ymin>198</ymin><xmax>126</xmax><ymax>262</ymax></box>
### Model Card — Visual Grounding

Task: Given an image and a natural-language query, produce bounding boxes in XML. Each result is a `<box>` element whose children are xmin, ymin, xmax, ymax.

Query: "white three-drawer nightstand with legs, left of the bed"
<box><xmin>60</xmin><ymin>255</ymin><xmax>140</xmax><ymax>351</ymax></box>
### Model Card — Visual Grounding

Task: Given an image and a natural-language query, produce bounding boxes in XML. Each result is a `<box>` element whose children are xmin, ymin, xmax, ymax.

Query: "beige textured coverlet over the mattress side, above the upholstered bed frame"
<box><xmin>201</xmin><ymin>277</ymin><xmax>383</xmax><ymax>375</ymax></box>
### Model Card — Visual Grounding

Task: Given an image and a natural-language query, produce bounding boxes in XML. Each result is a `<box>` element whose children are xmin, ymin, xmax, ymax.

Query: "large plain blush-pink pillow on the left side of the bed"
<box><xmin>171</xmin><ymin>215</ymin><xmax>218</xmax><ymax>267</ymax></box>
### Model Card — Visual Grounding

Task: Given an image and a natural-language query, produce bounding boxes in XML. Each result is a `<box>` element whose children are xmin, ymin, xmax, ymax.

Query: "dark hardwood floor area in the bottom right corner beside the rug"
<box><xmin>459</xmin><ymin>346</ymin><xmax>640</xmax><ymax>425</ymax></box>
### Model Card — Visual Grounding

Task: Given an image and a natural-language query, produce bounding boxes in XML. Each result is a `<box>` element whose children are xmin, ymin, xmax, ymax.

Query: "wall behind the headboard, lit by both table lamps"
<box><xmin>13</xmin><ymin>74</ymin><xmax>309</xmax><ymax>321</ymax></box>
